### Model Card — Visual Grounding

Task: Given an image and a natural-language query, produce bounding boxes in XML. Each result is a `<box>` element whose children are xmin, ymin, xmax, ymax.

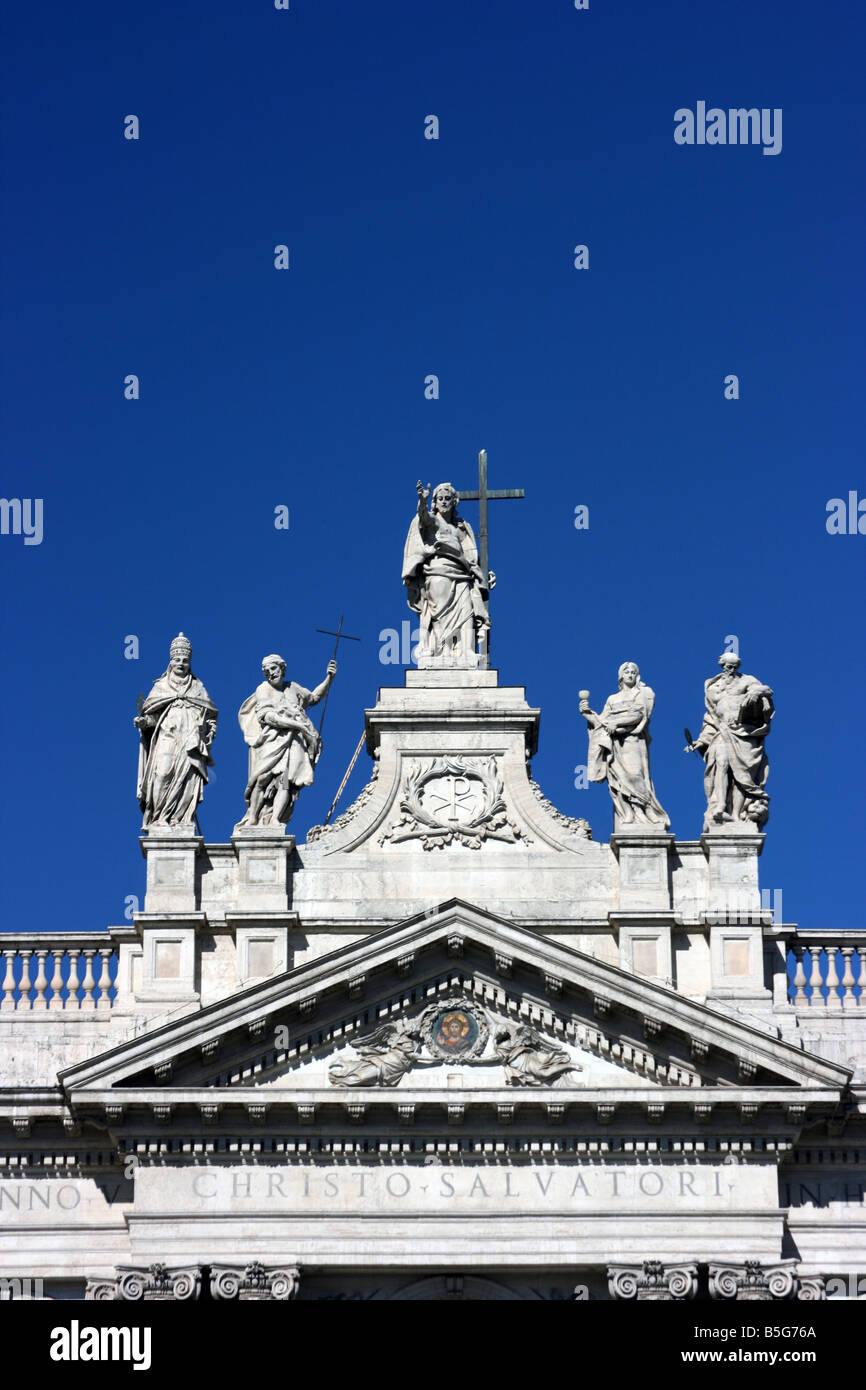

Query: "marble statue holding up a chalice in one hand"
<box><xmin>580</xmin><ymin>662</ymin><xmax>670</xmax><ymax>830</ymax></box>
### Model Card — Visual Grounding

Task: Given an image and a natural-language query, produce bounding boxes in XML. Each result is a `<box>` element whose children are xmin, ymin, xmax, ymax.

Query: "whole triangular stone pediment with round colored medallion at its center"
<box><xmin>60</xmin><ymin>901</ymin><xmax>849</xmax><ymax>1128</ymax></box>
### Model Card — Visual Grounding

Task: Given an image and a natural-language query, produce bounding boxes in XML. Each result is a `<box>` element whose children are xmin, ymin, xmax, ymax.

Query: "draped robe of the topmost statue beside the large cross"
<box><xmin>403</xmin><ymin>513</ymin><xmax>489</xmax><ymax>653</ymax></box>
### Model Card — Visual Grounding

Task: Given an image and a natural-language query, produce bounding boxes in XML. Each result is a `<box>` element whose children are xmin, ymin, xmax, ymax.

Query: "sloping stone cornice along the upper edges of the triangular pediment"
<box><xmin>58</xmin><ymin>899</ymin><xmax>851</xmax><ymax>1099</ymax></box>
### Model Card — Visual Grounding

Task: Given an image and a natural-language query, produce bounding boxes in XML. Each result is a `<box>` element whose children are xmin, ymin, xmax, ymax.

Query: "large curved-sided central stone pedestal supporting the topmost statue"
<box><xmin>292</xmin><ymin>669</ymin><xmax>617</xmax><ymax>926</ymax></box>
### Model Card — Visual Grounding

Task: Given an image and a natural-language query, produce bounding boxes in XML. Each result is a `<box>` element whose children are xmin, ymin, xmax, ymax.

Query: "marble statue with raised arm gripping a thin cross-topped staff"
<box><xmin>238</xmin><ymin>653</ymin><xmax>336</xmax><ymax>826</ymax></box>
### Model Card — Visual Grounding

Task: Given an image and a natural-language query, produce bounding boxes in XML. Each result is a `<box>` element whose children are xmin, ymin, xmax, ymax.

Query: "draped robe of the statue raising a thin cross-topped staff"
<box><xmin>238</xmin><ymin>681</ymin><xmax>321</xmax><ymax>806</ymax></box>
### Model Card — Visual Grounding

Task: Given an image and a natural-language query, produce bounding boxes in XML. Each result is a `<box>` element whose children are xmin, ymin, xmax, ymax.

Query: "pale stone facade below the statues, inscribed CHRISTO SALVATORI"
<box><xmin>0</xmin><ymin>664</ymin><xmax>866</xmax><ymax>1301</ymax></box>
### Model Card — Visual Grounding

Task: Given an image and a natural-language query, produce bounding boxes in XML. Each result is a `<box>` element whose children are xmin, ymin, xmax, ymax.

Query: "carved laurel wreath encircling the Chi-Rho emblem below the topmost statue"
<box><xmin>379</xmin><ymin>756</ymin><xmax>527</xmax><ymax>849</ymax></box>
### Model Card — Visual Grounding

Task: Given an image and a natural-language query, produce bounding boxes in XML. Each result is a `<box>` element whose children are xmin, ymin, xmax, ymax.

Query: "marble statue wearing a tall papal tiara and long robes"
<box><xmin>135</xmin><ymin>632</ymin><xmax>217</xmax><ymax>828</ymax></box>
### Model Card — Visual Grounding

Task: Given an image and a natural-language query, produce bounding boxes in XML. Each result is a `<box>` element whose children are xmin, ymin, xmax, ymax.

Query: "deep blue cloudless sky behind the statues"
<box><xmin>0</xmin><ymin>0</ymin><xmax>866</xmax><ymax>930</ymax></box>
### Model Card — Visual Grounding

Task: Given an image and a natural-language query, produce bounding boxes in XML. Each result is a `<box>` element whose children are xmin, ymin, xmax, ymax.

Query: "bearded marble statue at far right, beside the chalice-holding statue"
<box><xmin>685</xmin><ymin>652</ymin><xmax>774</xmax><ymax>830</ymax></box>
